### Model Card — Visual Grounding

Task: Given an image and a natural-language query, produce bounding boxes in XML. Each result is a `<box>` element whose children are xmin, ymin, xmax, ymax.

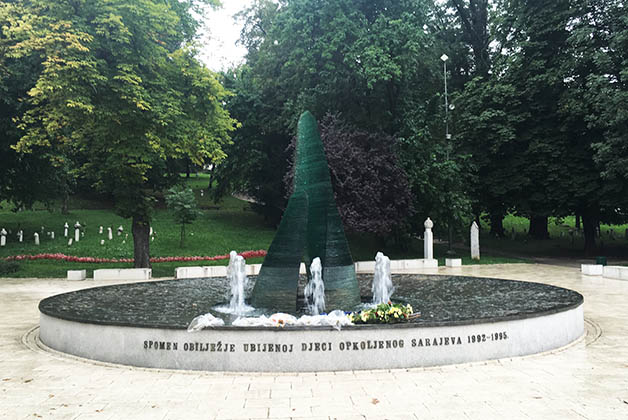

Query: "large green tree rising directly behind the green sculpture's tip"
<box><xmin>217</xmin><ymin>0</ymin><xmax>442</xmax><ymax>235</ymax></box>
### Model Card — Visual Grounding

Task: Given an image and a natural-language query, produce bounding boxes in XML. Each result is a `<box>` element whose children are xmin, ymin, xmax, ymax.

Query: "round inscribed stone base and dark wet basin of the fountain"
<box><xmin>40</xmin><ymin>275</ymin><xmax>584</xmax><ymax>372</ymax></box>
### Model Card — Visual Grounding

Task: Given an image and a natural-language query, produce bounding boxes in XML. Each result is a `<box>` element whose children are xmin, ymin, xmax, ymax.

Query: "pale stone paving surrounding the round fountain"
<box><xmin>0</xmin><ymin>264</ymin><xmax>628</xmax><ymax>420</ymax></box>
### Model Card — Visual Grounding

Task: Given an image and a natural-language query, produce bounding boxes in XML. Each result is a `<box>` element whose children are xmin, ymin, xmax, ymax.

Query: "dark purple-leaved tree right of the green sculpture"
<box><xmin>285</xmin><ymin>114</ymin><xmax>413</xmax><ymax>237</ymax></box>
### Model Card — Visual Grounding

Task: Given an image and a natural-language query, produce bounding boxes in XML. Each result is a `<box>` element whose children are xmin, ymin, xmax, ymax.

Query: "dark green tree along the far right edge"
<box><xmin>561</xmin><ymin>0</ymin><xmax>628</xmax><ymax>253</ymax></box>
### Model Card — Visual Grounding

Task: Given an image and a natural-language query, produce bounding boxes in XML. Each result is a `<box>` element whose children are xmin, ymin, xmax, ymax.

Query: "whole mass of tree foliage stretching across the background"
<box><xmin>0</xmin><ymin>0</ymin><xmax>628</xmax><ymax>255</ymax></box>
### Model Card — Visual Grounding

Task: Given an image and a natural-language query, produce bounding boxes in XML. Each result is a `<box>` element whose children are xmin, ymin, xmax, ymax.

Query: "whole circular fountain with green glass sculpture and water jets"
<box><xmin>39</xmin><ymin>113</ymin><xmax>584</xmax><ymax>371</ymax></box>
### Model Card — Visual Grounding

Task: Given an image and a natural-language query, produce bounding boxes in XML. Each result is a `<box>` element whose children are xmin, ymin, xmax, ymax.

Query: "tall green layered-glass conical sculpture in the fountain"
<box><xmin>251</xmin><ymin>111</ymin><xmax>360</xmax><ymax>313</ymax></box>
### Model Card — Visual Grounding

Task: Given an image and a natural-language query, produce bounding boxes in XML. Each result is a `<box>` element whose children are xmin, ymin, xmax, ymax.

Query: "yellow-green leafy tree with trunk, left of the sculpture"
<box><xmin>11</xmin><ymin>0</ymin><xmax>236</xmax><ymax>267</ymax></box>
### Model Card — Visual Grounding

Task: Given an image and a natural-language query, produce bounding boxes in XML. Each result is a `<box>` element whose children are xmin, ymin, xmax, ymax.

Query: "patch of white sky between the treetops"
<box><xmin>199</xmin><ymin>0</ymin><xmax>253</xmax><ymax>71</ymax></box>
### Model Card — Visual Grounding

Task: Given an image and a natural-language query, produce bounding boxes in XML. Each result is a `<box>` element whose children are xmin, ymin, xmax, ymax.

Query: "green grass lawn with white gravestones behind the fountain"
<box><xmin>0</xmin><ymin>174</ymin><xmax>540</xmax><ymax>277</ymax></box>
